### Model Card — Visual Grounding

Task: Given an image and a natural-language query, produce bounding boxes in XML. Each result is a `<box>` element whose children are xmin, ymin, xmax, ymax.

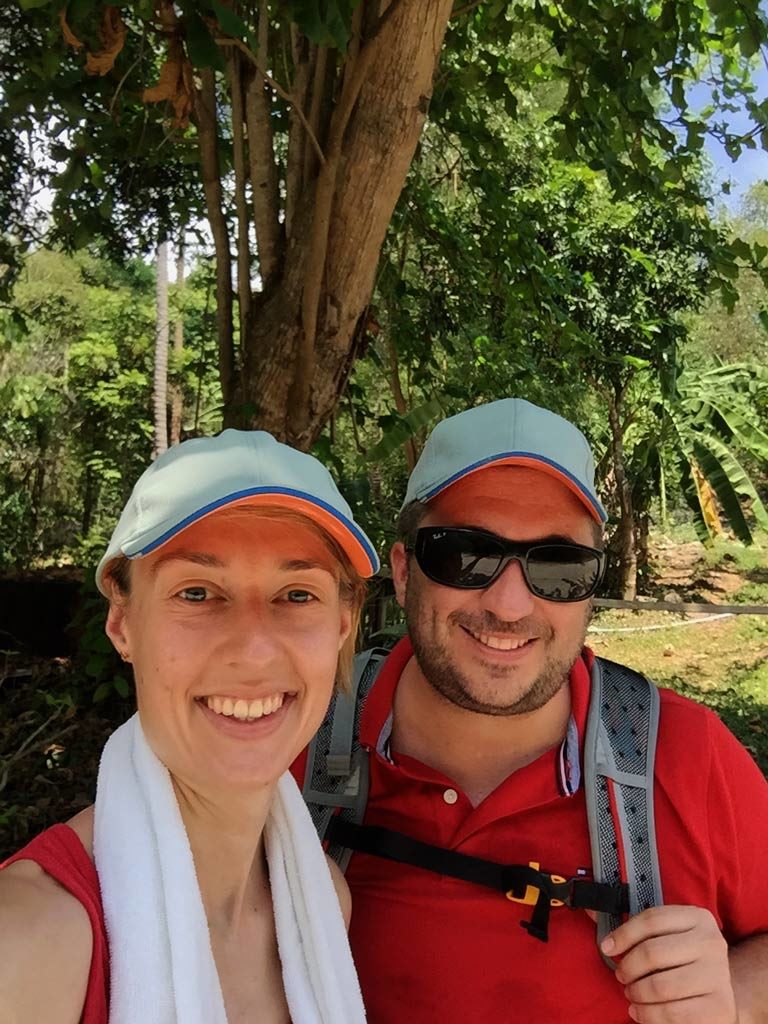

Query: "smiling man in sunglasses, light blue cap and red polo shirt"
<box><xmin>301</xmin><ymin>399</ymin><xmax>768</xmax><ymax>1024</ymax></box>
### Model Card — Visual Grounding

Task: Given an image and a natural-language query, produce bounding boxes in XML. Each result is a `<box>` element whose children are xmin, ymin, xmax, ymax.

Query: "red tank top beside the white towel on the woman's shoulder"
<box><xmin>0</xmin><ymin>825</ymin><xmax>110</xmax><ymax>1024</ymax></box>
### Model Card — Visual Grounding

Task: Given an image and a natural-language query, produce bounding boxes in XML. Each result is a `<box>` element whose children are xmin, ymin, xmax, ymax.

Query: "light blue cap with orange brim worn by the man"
<box><xmin>402</xmin><ymin>398</ymin><xmax>607</xmax><ymax>522</ymax></box>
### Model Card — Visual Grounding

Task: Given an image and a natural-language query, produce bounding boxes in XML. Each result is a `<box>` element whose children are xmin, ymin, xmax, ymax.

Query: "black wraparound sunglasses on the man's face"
<box><xmin>409</xmin><ymin>526</ymin><xmax>605</xmax><ymax>602</ymax></box>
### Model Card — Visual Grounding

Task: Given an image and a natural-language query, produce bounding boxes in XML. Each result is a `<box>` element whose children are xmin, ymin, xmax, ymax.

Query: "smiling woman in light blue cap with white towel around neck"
<box><xmin>0</xmin><ymin>430</ymin><xmax>378</xmax><ymax>1024</ymax></box>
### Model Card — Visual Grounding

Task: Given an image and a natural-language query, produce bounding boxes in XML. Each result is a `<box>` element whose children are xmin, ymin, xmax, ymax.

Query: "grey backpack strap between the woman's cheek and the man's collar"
<box><xmin>301</xmin><ymin>647</ymin><xmax>389</xmax><ymax>870</ymax></box>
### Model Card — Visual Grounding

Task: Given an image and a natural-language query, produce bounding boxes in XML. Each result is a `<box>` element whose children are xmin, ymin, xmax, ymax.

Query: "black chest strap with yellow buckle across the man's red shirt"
<box><xmin>326</xmin><ymin>815</ymin><xmax>629</xmax><ymax>942</ymax></box>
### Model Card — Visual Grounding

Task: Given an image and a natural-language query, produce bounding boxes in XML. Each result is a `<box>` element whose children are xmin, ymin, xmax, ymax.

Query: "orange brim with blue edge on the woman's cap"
<box><xmin>123</xmin><ymin>487</ymin><xmax>379</xmax><ymax>578</ymax></box>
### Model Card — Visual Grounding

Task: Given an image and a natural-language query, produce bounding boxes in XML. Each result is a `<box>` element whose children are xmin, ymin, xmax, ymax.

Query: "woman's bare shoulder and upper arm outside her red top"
<box><xmin>0</xmin><ymin>815</ymin><xmax>93</xmax><ymax>1024</ymax></box>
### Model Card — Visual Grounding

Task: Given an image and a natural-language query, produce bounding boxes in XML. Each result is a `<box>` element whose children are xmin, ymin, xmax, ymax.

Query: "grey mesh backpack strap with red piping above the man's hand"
<box><xmin>584</xmin><ymin>657</ymin><xmax>664</xmax><ymax>968</ymax></box>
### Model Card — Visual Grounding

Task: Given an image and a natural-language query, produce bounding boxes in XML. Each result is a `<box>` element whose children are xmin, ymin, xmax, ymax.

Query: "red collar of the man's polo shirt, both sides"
<box><xmin>360</xmin><ymin>637</ymin><xmax>594</xmax><ymax>797</ymax></box>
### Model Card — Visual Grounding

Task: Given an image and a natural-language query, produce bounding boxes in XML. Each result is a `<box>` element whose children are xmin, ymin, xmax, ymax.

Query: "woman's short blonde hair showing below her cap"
<box><xmin>104</xmin><ymin>504</ymin><xmax>366</xmax><ymax>693</ymax></box>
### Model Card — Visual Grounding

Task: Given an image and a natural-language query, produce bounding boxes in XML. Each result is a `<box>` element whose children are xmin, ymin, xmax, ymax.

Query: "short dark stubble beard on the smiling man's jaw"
<box><xmin>404</xmin><ymin>580</ymin><xmax>592</xmax><ymax>717</ymax></box>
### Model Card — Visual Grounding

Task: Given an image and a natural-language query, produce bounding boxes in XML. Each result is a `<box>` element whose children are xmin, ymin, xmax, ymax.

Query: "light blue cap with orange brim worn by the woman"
<box><xmin>96</xmin><ymin>430</ymin><xmax>379</xmax><ymax>594</ymax></box>
